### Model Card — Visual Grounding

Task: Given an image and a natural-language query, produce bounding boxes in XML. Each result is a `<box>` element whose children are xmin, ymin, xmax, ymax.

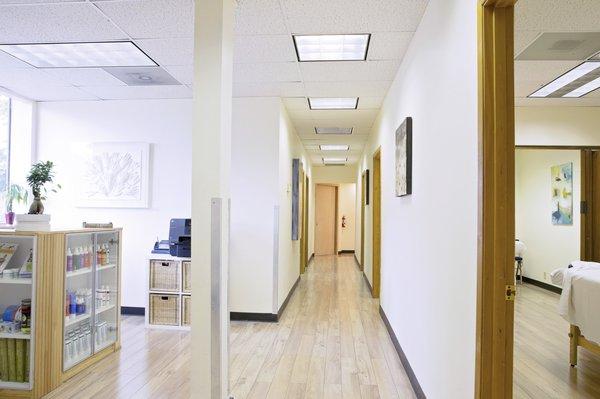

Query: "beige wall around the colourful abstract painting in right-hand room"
<box><xmin>515</xmin><ymin>149</ymin><xmax>581</xmax><ymax>284</ymax></box>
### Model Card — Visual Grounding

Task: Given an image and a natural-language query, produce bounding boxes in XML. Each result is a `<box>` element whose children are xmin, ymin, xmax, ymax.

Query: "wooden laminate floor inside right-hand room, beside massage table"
<box><xmin>514</xmin><ymin>284</ymin><xmax>600</xmax><ymax>399</ymax></box>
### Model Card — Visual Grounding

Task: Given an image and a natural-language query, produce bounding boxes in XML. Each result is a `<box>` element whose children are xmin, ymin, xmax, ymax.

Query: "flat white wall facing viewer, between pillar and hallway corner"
<box><xmin>229</xmin><ymin>98</ymin><xmax>280</xmax><ymax>313</ymax></box>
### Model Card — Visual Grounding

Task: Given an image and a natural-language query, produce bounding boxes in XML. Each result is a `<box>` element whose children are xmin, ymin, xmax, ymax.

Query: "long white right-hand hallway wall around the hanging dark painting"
<box><xmin>356</xmin><ymin>1</ymin><xmax>478</xmax><ymax>398</ymax></box>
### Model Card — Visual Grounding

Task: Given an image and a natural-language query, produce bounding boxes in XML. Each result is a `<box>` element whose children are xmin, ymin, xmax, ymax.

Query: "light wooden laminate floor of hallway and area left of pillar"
<box><xmin>46</xmin><ymin>256</ymin><xmax>414</xmax><ymax>399</ymax></box>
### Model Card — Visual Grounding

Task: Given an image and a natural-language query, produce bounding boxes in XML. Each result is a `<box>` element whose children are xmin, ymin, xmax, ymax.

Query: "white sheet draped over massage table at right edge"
<box><xmin>559</xmin><ymin>267</ymin><xmax>600</xmax><ymax>342</ymax></box>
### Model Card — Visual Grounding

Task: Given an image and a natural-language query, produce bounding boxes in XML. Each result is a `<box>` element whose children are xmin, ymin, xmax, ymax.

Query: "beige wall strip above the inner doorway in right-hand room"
<box><xmin>515</xmin><ymin>106</ymin><xmax>600</xmax><ymax>146</ymax></box>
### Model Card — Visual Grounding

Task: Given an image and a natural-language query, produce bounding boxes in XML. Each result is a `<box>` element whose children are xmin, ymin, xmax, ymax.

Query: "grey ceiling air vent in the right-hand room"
<box><xmin>515</xmin><ymin>32</ymin><xmax>600</xmax><ymax>61</ymax></box>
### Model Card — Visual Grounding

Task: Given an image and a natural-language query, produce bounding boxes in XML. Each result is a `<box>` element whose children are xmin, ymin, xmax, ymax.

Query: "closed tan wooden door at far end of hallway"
<box><xmin>315</xmin><ymin>184</ymin><xmax>336</xmax><ymax>255</ymax></box>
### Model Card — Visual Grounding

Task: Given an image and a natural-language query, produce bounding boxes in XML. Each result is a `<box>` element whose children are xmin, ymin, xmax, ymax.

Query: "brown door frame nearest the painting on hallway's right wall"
<box><xmin>371</xmin><ymin>147</ymin><xmax>381</xmax><ymax>298</ymax></box>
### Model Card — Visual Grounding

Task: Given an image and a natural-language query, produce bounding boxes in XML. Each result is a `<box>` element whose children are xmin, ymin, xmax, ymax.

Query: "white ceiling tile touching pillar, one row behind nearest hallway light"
<box><xmin>233</xmin><ymin>62</ymin><xmax>300</xmax><ymax>82</ymax></box>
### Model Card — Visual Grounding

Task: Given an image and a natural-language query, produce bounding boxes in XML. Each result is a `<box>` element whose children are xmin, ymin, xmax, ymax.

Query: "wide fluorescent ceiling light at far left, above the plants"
<box><xmin>0</xmin><ymin>41</ymin><xmax>157</xmax><ymax>68</ymax></box>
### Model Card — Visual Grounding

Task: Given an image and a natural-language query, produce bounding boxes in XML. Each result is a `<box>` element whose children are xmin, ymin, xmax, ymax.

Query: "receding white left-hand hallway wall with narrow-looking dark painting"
<box><xmin>273</xmin><ymin>103</ymin><xmax>311</xmax><ymax>313</ymax></box>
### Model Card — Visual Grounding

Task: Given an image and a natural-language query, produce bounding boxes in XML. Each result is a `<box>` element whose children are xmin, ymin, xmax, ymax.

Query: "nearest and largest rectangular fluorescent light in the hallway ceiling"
<box><xmin>293</xmin><ymin>33</ymin><xmax>371</xmax><ymax>62</ymax></box>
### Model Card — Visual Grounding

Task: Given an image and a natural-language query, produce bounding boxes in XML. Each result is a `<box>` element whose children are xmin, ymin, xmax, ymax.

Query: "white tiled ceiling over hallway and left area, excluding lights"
<box><xmin>0</xmin><ymin>0</ymin><xmax>427</xmax><ymax>163</ymax></box>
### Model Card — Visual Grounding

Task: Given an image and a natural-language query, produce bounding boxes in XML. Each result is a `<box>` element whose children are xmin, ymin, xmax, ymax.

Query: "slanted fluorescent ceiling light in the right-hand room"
<box><xmin>529</xmin><ymin>61</ymin><xmax>600</xmax><ymax>98</ymax></box>
